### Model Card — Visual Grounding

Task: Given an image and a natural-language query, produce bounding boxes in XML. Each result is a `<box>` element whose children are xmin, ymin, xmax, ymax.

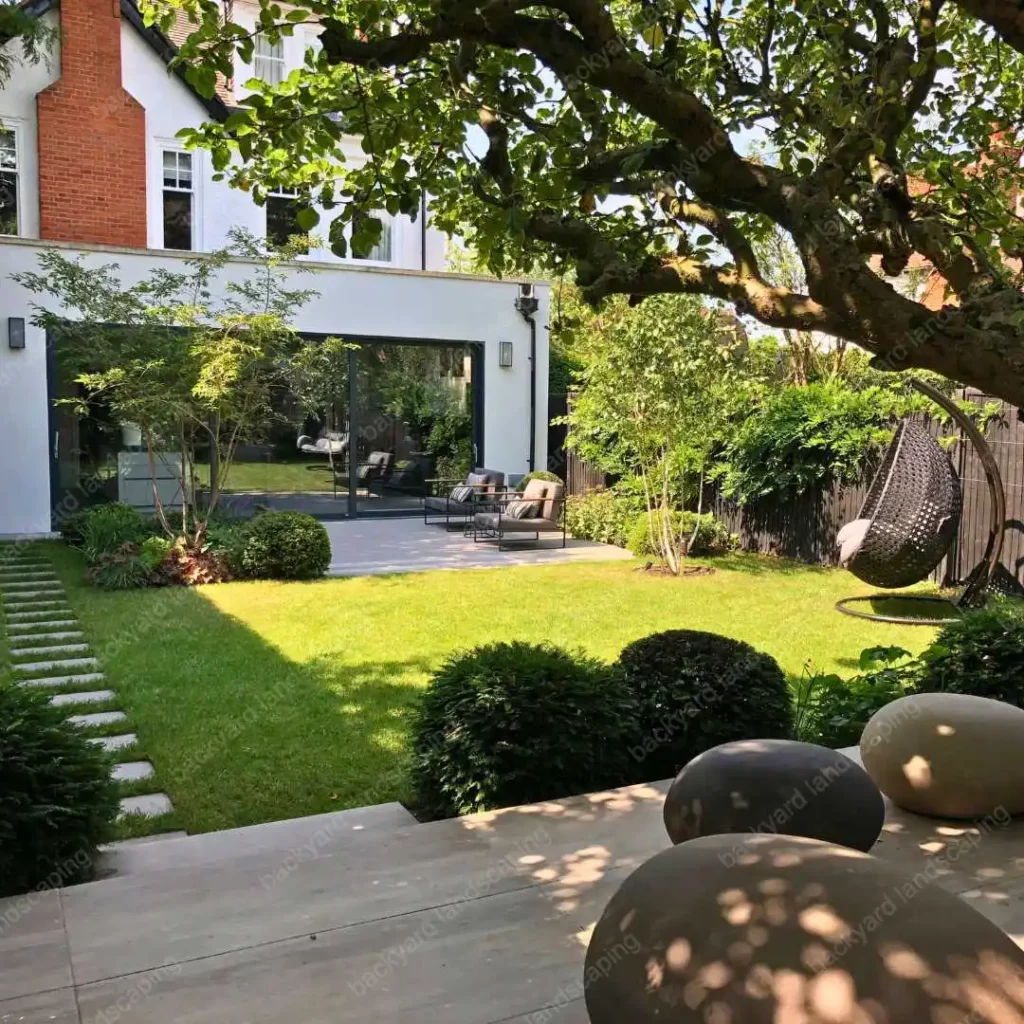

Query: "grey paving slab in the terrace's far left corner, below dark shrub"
<box><xmin>0</xmin><ymin>889</ymin><xmax>72</xmax><ymax>999</ymax></box>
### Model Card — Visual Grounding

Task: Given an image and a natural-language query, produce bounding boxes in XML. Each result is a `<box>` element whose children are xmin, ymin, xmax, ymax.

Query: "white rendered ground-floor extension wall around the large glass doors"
<box><xmin>0</xmin><ymin>240</ymin><xmax>549</xmax><ymax>535</ymax></box>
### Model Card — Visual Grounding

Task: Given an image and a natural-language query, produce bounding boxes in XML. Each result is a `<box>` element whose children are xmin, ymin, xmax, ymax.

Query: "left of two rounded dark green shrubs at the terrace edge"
<box><xmin>413</xmin><ymin>642</ymin><xmax>635</xmax><ymax>816</ymax></box>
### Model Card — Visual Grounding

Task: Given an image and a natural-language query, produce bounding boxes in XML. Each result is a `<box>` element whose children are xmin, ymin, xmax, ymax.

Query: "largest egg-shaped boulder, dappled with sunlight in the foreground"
<box><xmin>584</xmin><ymin>835</ymin><xmax>1024</xmax><ymax>1024</ymax></box>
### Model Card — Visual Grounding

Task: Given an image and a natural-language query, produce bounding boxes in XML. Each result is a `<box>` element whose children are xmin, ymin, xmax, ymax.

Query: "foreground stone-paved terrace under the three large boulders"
<box><xmin>6</xmin><ymin>753</ymin><xmax>1024</xmax><ymax>1024</ymax></box>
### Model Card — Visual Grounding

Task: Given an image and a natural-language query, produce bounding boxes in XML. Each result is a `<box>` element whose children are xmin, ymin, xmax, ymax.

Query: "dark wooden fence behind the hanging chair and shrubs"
<box><xmin>549</xmin><ymin>391</ymin><xmax>1024</xmax><ymax>583</ymax></box>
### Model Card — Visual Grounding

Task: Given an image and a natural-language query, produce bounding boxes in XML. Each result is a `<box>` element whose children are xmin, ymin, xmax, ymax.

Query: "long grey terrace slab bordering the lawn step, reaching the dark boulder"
<box><xmin>65</xmin><ymin>786</ymin><xmax>669</xmax><ymax>981</ymax></box>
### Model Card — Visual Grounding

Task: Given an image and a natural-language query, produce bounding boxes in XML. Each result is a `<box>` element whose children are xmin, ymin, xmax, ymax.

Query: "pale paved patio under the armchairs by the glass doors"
<box><xmin>324</xmin><ymin>518</ymin><xmax>632</xmax><ymax>575</ymax></box>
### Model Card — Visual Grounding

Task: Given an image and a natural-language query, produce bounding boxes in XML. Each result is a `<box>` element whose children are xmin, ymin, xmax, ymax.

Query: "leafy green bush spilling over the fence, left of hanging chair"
<box><xmin>722</xmin><ymin>380</ymin><xmax>895</xmax><ymax>502</ymax></box>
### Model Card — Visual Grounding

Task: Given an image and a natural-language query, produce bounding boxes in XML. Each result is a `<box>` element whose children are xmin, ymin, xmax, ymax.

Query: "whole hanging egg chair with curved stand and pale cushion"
<box><xmin>837</xmin><ymin>380</ymin><xmax>1006</xmax><ymax>625</ymax></box>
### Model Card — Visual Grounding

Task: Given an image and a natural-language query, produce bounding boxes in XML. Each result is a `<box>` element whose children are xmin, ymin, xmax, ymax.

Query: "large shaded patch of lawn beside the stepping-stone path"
<box><xmin>74</xmin><ymin>590</ymin><xmax>432</xmax><ymax>833</ymax></box>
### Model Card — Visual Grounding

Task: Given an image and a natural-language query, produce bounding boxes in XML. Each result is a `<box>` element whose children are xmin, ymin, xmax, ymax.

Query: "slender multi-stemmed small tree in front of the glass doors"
<box><xmin>13</xmin><ymin>229</ymin><xmax>315</xmax><ymax>550</ymax></box>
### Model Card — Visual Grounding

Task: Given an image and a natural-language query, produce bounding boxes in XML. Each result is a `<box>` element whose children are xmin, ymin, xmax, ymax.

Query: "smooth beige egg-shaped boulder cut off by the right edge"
<box><xmin>860</xmin><ymin>692</ymin><xmax>1024</xmax><ymax>818</ymax></box>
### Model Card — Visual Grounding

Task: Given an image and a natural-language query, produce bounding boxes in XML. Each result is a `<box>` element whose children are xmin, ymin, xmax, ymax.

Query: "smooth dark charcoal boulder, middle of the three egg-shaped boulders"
<box><xmin>665</xmin><ymin>739</ymin><xmax>886</xmax><ymax>851</ymax></box>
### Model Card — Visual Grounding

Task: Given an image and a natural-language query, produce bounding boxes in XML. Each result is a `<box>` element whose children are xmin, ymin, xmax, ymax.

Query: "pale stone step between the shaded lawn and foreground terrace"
<box><xmin>93</xmin><ymin>803</ymin><xmax>419</xmax><ymax>877</ymax></box>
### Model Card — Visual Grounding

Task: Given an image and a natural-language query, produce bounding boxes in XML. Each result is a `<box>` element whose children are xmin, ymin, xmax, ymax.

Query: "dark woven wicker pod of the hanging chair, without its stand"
<box><xmin>846</xmin><ymin>420</ymin><xmax>961</xmax><ymax>590</ymax></box>
